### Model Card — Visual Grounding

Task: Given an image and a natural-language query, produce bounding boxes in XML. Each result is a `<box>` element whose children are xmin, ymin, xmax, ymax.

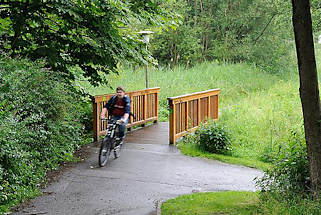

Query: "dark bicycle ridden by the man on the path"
<box><xmin>98</xmin><ymin>118</ymin><xmax>122</xmax><ymax>167</ymax></box>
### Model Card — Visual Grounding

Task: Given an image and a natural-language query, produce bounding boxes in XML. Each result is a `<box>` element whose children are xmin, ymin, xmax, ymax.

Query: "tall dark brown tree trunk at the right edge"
<box><xmin>292</xmin><ymin>0</ymin><xmax>321</xmax><ymax>193</ymax></box>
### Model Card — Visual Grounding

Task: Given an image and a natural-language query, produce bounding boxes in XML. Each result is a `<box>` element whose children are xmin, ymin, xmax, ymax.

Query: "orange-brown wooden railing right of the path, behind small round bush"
<box><xmin>167</xmin><ymin>89</ymin><xmax>220</xmax><ymax>144</ymax></box>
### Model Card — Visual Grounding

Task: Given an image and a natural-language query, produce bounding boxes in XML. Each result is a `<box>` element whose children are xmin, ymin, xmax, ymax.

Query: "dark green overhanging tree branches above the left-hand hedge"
<box><xmin>0</xmin><ymin>0</ymin><xmax>175</xmax><ymax>84</ymax></box>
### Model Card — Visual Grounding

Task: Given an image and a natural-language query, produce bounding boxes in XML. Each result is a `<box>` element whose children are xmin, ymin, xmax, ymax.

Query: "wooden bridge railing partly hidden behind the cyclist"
<box><xmin>92</xmin><ymin>87</ymin><xmax>160</xmax><ymax>141</ymax></box>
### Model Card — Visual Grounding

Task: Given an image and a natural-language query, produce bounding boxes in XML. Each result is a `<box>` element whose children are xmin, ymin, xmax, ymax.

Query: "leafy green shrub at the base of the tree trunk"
<box><xmin>257</xmin><ymin>128</ymin><xmax>311</xmax><ymax>195</ymax></box>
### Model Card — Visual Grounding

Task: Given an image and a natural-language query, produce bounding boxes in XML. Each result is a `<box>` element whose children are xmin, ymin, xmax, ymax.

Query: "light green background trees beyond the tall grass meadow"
<box><xmin>151</xmin><ymin>0</ymin><xmax>293</xmax><ymax>72</ymax></box>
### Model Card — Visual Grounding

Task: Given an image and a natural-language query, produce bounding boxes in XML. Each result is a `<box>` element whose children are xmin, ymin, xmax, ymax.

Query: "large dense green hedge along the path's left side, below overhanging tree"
<box><xmin>0</xmin><ymin>57</ymin><xmax>83</xmax><ymax>211</ymax></box>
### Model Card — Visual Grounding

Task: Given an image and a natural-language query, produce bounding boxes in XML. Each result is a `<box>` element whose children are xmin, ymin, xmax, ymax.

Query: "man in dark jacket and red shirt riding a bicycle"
<box><xmin>100</xmin><ymin>86</ymin><xmax>130</xmax><ymax>148</ymax></box>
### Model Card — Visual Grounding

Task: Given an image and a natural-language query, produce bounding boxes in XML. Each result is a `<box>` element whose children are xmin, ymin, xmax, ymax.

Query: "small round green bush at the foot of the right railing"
<box><xmin>195</xmin><ymin>121</ymin><xmax>231</xmax><ymax>154</ymax></box>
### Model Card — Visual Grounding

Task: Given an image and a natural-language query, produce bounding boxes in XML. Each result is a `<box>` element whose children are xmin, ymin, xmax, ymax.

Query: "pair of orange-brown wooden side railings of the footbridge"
<box><xmin>92</xmin><ymin>87</ymin><xmax>220</xmax><ymax>144</ymax></box>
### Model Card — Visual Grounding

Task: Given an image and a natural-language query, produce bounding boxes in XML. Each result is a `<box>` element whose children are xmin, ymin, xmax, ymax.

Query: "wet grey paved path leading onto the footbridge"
<box><xmin>13</xmin><ymin>123</ymin><xmax>262</xmax><ymax>215</ymax></box>
